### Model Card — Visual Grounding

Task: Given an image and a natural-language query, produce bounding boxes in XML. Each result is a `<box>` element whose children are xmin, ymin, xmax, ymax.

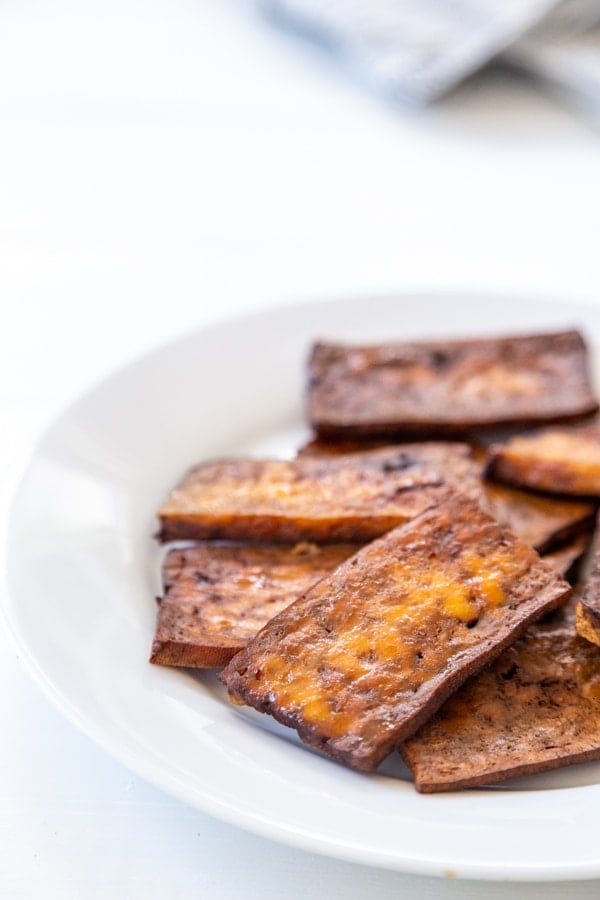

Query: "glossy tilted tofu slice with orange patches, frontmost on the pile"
<box><xmin>221</xmin><ymin>491</ymin><xmax>570</xmax><ymax>771</ymax></box>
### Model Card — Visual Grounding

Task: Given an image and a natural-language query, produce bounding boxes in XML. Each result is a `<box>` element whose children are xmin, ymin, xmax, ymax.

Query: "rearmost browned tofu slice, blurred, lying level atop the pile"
<box><xmin>308</xmin><ymin>331</ymin><xmax>598</xmax><ymax>437</ymax></box>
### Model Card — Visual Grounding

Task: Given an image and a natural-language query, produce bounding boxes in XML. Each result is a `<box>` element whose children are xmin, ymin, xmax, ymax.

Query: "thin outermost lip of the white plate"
<box><xmin>0</xmin><ymin>291</ymin><xmax>600</xmax><ymax>882</ymax></box>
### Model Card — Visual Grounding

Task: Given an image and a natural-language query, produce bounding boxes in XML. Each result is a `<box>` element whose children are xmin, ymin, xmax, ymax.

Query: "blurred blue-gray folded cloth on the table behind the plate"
<box><xmin>256</xmin><ymin>0</ymin><xmax>600</xmax><ymax>104</ymax></box>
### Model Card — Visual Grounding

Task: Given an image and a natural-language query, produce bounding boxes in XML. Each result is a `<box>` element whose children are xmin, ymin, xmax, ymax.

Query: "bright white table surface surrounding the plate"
<box><xmin>0</xmin><ymin>0</ymin><xmax>600</xmax><ymax>900</ymax></box>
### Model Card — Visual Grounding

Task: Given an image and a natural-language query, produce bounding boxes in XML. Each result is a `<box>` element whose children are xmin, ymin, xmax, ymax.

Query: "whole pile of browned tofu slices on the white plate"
<box><xmin>151</xmin><ymin>331</ymin><xmax>600</xmax><ymax>791</ymax></box>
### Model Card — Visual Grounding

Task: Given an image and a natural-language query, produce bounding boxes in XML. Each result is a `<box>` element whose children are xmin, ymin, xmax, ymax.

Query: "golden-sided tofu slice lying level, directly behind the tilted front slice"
<box><xmin>158</xmin><ymin>448</ymin><xmax>452</xmax><ymax>544</ymax></box>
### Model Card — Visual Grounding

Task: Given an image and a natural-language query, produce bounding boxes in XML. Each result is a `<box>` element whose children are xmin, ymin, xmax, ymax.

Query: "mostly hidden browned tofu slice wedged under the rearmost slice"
<box><xmin>298</xmin><ymin>439</ymin><xmax>594</xmax><ymax>553</ymax></box>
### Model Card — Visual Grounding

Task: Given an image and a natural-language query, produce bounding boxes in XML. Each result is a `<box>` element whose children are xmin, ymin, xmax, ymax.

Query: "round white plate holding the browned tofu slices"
<box><xmin>5</xmin><ymin>296</ymin><xmax>600</xmax><ymax>880</ymax></box>
